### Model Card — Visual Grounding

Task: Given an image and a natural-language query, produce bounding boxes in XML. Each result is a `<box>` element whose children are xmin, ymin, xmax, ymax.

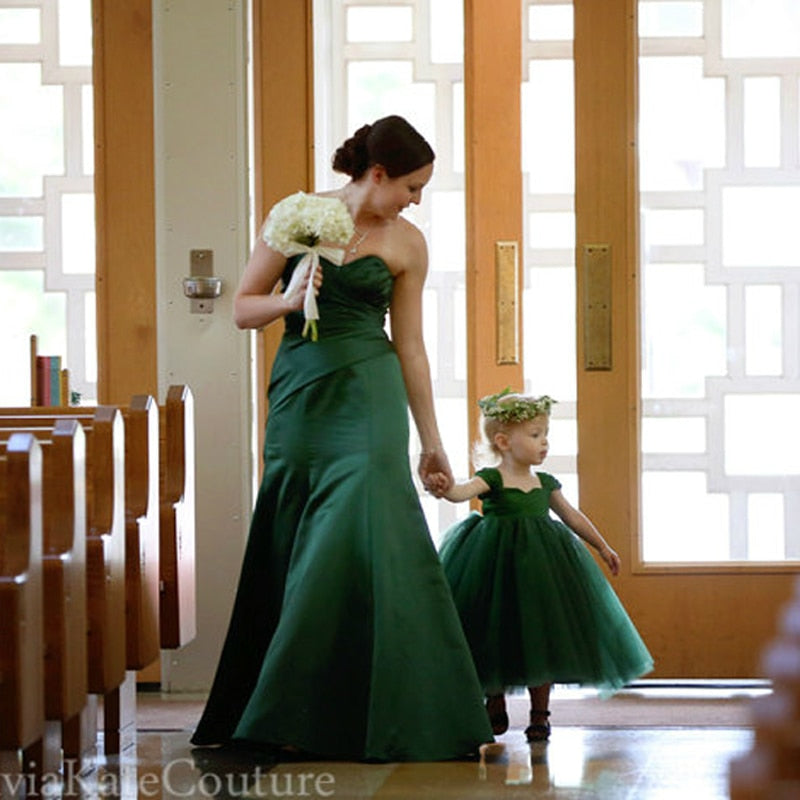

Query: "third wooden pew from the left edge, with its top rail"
<box><xmin>0</xmin><ymin>406</ymin><xmax>127</xmax><ymax>754</ymax></box>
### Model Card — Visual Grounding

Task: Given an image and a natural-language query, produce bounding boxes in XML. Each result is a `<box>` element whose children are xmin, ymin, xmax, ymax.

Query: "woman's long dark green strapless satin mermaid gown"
<box><xmin>192</xmin><ymin>256</ymin><xmax>492</xmax><ymax>761</ymax></box>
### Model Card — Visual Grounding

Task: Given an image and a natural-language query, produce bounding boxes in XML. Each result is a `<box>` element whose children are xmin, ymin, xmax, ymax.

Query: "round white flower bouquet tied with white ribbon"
<box><xmin>261</xmin><ymin>192</ymin><xmax>355</xmax><ymax>341</ymax></box>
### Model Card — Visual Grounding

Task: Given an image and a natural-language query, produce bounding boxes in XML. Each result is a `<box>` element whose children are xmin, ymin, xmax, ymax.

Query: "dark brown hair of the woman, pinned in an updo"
<box><xmin>333</xmin><ymin>115</ymin><xmax>435</xmax><ymax>180</ymax></box>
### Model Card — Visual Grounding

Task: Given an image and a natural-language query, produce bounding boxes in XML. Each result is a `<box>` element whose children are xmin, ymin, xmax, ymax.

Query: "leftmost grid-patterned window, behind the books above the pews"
<box><xmin>0</xmin><ymin>0</ymin><xmax>97</xmax><ymax>405</ymax></box>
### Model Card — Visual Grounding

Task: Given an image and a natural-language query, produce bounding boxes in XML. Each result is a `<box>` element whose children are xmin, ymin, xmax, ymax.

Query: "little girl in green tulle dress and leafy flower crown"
<box><xmin>441</xmin><ymin>389</ymin><xmax>653</xmax><ymax>742</ymax></box>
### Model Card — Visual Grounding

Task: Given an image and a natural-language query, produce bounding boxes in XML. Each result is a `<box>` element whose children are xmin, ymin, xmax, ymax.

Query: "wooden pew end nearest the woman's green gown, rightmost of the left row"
<box><xmin>160</xmin><ymin>385</ymin><xmax>197</xmax><ymax>649</ymax></box>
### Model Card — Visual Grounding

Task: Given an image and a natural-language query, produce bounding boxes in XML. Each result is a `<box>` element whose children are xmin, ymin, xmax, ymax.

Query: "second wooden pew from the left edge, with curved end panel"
<box><xmin>0</xmin><ymin>419</ymin><xmax>91</xmax><ymax>761</ymax></box>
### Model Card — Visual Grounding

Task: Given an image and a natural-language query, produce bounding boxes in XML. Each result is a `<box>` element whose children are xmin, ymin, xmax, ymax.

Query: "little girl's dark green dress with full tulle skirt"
<box><xmin>440</xmin><ymin>468</ymin><xmax>653</xmax><ymax>694</ymax></box>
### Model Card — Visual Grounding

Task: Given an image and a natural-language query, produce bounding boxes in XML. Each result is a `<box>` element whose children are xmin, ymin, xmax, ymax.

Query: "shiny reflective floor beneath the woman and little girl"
<box><xmin>37</xmin><ymin>685</ymin><xmax>769</xmax><ymax>800</ymax></box>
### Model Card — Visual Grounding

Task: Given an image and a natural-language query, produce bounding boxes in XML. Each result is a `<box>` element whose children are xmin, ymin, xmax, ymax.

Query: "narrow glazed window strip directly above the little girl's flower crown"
<box><xmin>522</xmin><ymin>0</ymin><xmax>578</xmax><ymax>502</ymax></box>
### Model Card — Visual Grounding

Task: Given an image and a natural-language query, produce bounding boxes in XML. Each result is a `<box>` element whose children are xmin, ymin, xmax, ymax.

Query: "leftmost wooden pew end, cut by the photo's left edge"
<box><xmin>0</xmin><ymin>434</ymin><xmax>44</xmax><ymax>794</ymax></box>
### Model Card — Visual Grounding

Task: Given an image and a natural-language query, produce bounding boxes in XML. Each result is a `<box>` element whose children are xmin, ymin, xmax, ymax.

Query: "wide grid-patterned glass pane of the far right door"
<box><xmin>639</xmin><ymin>0</ymin><xmax>800</xmax><ymax>563</ymax></box>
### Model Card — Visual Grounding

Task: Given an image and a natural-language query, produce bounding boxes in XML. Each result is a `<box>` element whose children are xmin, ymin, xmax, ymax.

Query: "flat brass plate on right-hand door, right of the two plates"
<box><xmin>583</xmin><ymin>244</ymin><xmax>611</xmax><ymax>370</ymax></box>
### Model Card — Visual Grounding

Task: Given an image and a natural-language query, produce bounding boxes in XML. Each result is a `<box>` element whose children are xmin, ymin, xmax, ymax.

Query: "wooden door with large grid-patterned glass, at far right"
<box><xmin>575</xmin><ymin>0</ymin><xmax>800</xmax><ymax>678</ymax></box>
